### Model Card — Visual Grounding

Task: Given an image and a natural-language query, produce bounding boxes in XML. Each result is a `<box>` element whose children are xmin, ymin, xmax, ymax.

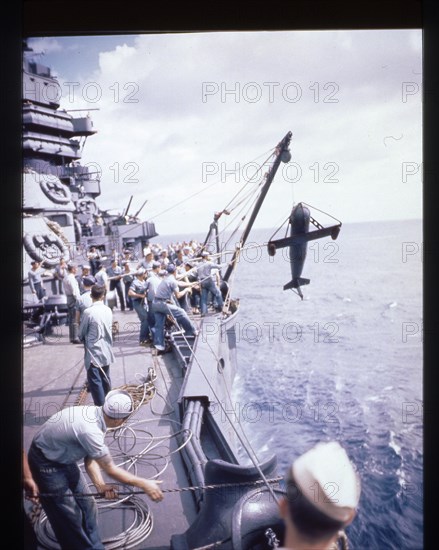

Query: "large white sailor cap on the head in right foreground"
<box><xmin>291</xmin><ymin>441</ymin><xmax>361</xmax><ymax>522</ymax></box>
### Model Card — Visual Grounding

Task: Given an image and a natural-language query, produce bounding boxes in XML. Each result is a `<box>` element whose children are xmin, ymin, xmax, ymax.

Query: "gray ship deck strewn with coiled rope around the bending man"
<box><xmin>22</xmin><ymin>310</ymin><xmax>197</xmax><ymax>549</ymax></box>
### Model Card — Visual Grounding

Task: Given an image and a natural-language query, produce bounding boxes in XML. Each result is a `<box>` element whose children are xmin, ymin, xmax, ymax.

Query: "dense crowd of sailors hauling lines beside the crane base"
<box><xmin>102</xmin><ymin>245</ymin><xmax>224</xmax><ymax>353</ymax></box>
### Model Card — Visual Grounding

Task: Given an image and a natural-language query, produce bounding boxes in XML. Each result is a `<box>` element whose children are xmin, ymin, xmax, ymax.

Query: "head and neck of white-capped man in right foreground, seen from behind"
<box><xmin>279</xmin><ymin>441</ymin><xmax>361</xmax><ymax>550</ymax></box>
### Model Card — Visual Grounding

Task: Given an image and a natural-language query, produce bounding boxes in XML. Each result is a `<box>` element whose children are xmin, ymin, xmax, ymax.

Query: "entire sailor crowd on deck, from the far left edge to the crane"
<box><xmin>28</xmin><ymin>241</ymin><xmax>227</xmax><ymax>353</ymax></box>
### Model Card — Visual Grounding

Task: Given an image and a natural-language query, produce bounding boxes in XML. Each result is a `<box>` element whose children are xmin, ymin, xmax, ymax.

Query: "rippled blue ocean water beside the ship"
<box><xmin>163</xmin><ymin>220</ymin><xmax>423</xmax><ymax>550</ymax></box>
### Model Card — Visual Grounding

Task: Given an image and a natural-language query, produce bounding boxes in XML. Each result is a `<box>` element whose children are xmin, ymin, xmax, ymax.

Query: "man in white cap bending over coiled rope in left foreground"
<box><xmin>28</xmin><ymin>390</ymin><xmax>163</xmax><ymax>550</ymax></box>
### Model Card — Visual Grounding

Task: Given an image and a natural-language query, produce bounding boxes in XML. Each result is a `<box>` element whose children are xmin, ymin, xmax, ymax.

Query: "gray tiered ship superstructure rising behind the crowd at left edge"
<box><xmin>22</xmin><ymin>43</ymin><xmax>157</xmax><ymax>304</ymax></box>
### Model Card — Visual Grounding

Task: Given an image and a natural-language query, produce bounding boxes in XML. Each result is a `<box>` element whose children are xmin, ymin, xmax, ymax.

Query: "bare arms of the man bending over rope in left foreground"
<box><xmin>84</xmin><ymin>454</ymin><xmax>163</xmax><ymax>502</ymax></box>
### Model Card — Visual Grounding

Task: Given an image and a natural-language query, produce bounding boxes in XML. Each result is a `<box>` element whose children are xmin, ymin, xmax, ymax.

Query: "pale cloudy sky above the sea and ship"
<box><xmin>29</xmin><ymin>29</ymin><xmax>422</xmax><ymax>235</ymax></box>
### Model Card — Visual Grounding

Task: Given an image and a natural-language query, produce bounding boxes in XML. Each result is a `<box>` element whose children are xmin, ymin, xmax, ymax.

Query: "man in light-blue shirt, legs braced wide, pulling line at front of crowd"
<box><xmin>152</xmin><ymin>264</ymin><xmax>198</xmax><ymax>352</ymax></box>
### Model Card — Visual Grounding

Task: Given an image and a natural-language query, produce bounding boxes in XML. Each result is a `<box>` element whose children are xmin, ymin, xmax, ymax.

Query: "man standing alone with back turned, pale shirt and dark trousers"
<box><xmin>79</xmin><ymin>285</ymin><xmax>114</xmax><ymax>405</ymax></box>
